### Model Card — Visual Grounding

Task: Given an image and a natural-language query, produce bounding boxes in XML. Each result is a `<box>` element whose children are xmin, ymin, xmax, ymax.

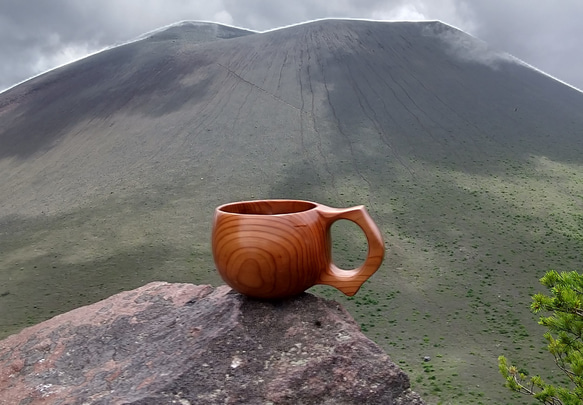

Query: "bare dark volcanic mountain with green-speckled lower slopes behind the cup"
<box><xmin>0</xmin><ymin>20</ymin><xmax>583</xmax><ymax>404</ymax></box>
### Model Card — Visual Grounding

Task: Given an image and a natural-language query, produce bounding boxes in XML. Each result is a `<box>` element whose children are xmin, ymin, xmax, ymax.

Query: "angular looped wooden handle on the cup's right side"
<box><xmin>317</xmin><ymin>205</ymin><xmax>385</xmax><ymax>297</ymax></box>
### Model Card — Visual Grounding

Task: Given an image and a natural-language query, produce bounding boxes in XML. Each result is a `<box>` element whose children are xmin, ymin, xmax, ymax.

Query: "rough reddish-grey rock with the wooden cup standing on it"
<box><xmin>0</xmin><ymin>282</ymin><xmax>424</xmax><ymax>405</ymax></box>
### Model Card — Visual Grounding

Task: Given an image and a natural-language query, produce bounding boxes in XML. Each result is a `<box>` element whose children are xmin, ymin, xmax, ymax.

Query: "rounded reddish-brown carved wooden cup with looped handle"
<box><xmin>212</xmin><ymin>200</ymin><xmax>385</xmax><ymax>298</ymax></box>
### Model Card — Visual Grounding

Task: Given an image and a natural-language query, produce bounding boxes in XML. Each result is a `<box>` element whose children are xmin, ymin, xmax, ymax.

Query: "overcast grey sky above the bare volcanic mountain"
<box><xmin>0</xmin><ymin>0</ymin><xmax>583</xmax><ymax>91</ymax></box>
